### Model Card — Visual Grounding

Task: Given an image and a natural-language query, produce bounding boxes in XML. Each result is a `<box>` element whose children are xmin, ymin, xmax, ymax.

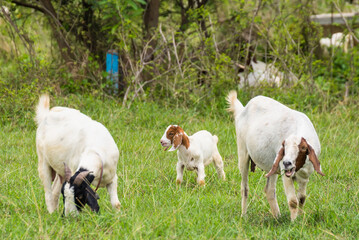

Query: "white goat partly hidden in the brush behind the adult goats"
<box><xmin>238</xmin><ymin>60</ymin><xmax>298</xmax><ymax>89</ymax></box>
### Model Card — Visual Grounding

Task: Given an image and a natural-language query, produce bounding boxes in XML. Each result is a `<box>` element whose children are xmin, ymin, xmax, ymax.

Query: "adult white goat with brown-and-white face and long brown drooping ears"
<box><xmin>227</xmin><ymin>91</ymin><xmax>324</xmax><ymax>221</ymax></box>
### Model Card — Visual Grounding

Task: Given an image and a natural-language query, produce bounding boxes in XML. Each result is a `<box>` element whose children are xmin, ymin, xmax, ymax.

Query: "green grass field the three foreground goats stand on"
<box><xmin>0</xmin><ymin>94</ymin><xmax>359</xmax><ymax>239</ymax></box>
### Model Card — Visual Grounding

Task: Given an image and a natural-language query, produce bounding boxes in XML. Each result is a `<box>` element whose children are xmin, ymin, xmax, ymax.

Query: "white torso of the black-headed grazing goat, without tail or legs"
<box><xmin>36</xmin><ymin>107</ymin><xmax>119</xmax><ymax>175</ymax></box>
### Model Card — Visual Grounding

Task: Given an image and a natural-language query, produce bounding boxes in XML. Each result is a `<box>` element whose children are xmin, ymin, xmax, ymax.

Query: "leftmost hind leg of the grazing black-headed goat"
<box><xmin>38</xmin><ymin>160</ymin><xmax>58</xmax><ymax>213</ymax></box>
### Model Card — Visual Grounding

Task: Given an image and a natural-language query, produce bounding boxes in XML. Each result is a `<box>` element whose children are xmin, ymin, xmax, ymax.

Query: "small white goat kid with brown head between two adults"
<box><xmin>161</xmin><ymin>125</ymin><xmax>226</xmax><ymax>185</ymax></box>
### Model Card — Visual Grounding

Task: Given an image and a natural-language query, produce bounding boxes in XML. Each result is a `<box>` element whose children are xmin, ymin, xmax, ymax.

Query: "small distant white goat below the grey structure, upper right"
<box><xmin>319</xmin><ymin>32</ymin><xmax>354</xmax><ymax>55</ymax></box>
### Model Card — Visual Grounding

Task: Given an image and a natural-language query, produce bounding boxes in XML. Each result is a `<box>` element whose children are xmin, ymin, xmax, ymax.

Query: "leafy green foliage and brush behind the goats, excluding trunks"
<box><xmin>0</xmin><ymin>0</ymin><xmax>359</xmax><ymax>120</ymax></box>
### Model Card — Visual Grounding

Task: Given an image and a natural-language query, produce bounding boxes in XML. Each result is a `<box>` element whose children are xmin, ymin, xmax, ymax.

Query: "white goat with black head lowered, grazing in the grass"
<box><xmin>36</xmin><ymin>95</ymin><xmax>120</xmax><ymax>216</ymax></box>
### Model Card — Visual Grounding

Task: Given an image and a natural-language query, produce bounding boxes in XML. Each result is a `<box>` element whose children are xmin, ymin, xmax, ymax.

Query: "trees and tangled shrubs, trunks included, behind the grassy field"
<box><xmin>2</xmin><ymin>0</ymin><xmax>358</xmax><ymax>110</ymax></box>
